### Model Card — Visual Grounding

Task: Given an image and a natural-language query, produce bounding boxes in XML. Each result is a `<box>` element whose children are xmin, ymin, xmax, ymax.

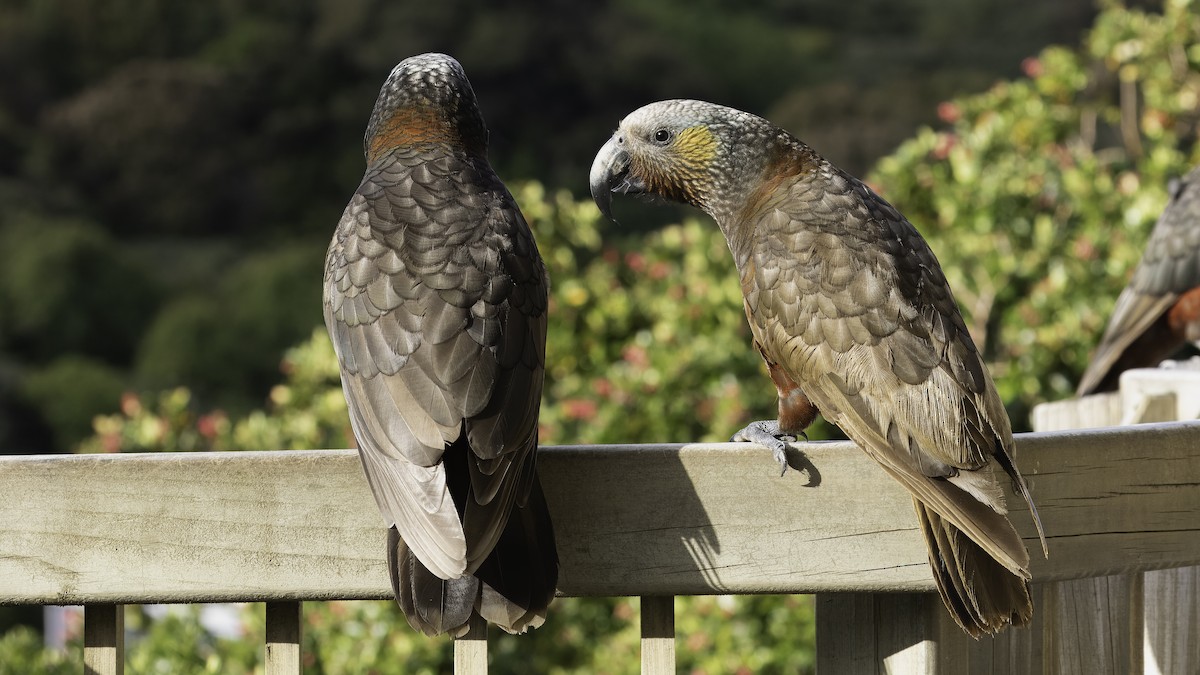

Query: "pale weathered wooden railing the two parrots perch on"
<box><xmin>0</xmin><ymin>423</ymin><xmax>1200</xmax><ymax>675</ymax></box>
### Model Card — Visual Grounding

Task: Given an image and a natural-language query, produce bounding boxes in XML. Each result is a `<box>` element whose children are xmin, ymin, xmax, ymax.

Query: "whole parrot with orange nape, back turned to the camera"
<box><xmin>324</xmin><ymin>54</ymin><xmax>558</xmax><ymax>635</ymax></box>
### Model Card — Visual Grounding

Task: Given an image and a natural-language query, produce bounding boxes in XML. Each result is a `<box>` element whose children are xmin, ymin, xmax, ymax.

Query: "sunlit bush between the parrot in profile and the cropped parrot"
<box><xmin>871</xmin><ymin>0</ymin><xmax>1200</xmax><ymax>429</ymax></box>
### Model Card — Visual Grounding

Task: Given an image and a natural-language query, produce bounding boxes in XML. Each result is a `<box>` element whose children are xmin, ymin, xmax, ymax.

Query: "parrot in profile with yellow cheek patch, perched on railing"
<box><xmin>590</xmin><ymin>100</ymin><xmax>1045</xmax><ymax>638</ymax></box>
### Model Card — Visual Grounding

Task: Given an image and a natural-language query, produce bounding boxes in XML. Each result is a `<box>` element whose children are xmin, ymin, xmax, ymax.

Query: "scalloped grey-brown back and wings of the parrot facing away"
<box><xmin>324</xmin><ymin>139</ymin><xmax>554</xmax><ymax>634</ymax></box>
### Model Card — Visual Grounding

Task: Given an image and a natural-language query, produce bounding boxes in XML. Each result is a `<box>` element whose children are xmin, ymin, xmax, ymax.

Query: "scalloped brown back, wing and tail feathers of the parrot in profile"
<box><xmin>744</xmin><ymin>159</ymin><xmax>1040</xmax><ymax>635</ymax></box>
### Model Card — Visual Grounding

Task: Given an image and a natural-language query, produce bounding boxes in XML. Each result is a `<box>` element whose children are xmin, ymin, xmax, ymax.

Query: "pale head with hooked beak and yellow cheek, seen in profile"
<box><xmin>590</xmin><ymin>100</ymin><xmax>780</xmax><ymax>219</ymax></box>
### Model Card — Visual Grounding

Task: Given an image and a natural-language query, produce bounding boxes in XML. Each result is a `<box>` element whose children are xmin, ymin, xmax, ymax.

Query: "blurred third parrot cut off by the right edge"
<box><xmin>1076</xmin><ymin>168</ymin><xmax>1200</xmax><ymax>396</ymax></box>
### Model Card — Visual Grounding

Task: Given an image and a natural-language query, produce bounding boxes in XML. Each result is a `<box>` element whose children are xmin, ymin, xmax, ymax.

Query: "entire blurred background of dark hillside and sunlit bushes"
<box><xmin>0</xmin><ymin>0</ymin><xmax>1200</xmax><ymax>674</ymax></box>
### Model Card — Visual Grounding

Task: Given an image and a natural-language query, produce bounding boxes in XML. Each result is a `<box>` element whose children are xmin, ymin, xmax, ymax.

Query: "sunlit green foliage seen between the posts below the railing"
<box><xmin>0</xmin><ymin>596</ymin><xmax>815</xmax><ymax>675</ymax></box>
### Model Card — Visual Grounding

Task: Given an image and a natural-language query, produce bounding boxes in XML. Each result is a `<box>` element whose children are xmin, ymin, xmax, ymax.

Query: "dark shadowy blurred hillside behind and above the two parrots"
<box><xmin>0</xmin><ymin>0</ymin><xmax>1094</xmax><ymax>452</ymax></box>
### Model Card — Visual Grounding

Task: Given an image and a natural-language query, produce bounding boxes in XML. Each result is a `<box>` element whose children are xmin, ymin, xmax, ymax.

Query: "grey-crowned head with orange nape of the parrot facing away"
<box><xmin>362</xmin><ymin>53</ymin><xmax>487</xmax><ymax>163</ymax></box>
